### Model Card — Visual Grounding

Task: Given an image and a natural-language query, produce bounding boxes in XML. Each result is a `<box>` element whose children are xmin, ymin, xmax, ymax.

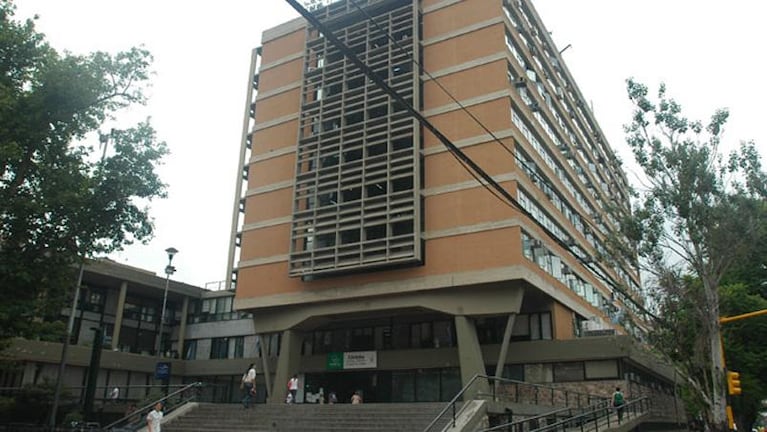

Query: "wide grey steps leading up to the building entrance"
<box><xmin>162</xmin><ymin>402</ymin><xmax>447</xmax><ymax>432</ymax></box>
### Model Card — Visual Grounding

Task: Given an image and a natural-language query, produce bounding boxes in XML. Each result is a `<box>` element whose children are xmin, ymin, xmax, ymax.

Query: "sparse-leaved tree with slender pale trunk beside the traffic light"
<box><xmin>620</xmin><ymin>80</ymin><xmax>767</xmax><ymax>430</ymax></box>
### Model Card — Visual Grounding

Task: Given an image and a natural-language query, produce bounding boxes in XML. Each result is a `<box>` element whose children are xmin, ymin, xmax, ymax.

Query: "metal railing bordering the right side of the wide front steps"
<box><xmin>423</xmin><ymin>374</ymin><xmax>610</xmax><ymax>432</ymax></box>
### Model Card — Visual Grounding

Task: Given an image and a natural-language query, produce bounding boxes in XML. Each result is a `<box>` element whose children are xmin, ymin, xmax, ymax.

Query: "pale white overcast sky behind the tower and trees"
<box><xmin>17</xmin><ymin>0</ymin><xmax>767</xmax><ymax>286</ymax></box>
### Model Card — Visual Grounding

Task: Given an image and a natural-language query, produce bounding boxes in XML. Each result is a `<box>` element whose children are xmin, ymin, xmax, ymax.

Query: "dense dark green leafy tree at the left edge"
<box><xmin>0</xmin><ymin>0</ymin><xmax>167</xmax><ymax>341</ymax></box>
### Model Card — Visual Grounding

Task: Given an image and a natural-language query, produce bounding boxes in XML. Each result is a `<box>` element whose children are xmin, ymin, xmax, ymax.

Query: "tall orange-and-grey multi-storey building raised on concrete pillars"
<box><xmin>230</xmin><ymin>0</ymin><xmax>670</xmax><ymax>401</ymax></box>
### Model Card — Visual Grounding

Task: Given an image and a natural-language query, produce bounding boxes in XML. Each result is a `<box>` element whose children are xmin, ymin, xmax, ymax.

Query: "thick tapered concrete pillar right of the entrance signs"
<box><xmin>455</xmin><ymin>315</ymin><xmax>488</xmax><ymax>400</ymax></box>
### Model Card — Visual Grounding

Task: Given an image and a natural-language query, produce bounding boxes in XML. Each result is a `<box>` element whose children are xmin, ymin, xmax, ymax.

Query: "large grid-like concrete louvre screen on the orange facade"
<box><xmin>290</xmin><ymin>0</ymin><xmax>423</xmax><ymax>277</ymax></box>
